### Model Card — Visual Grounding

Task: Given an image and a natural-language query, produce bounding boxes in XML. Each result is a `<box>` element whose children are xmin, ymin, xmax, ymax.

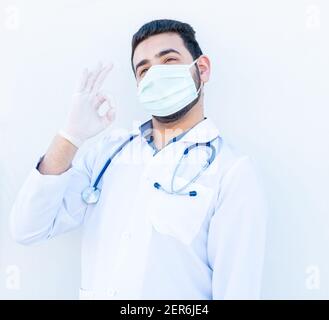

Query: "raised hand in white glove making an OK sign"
<box><xmin>59</xmin><ymin>63</ymin><xmax>115</xmax><ymax>148</ymax></box>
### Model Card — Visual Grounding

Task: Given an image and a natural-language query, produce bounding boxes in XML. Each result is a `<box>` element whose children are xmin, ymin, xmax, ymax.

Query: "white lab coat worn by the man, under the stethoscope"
<box><xmin>11</xmin><ymin>118</ymin><xmax>266</xmax><ymax>299</ymax></box>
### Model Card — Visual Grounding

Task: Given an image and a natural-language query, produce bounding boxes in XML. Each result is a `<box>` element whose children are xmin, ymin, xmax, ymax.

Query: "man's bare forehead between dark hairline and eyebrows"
<box><xmin>133</xmin><ymin>32</ymin><xmax>191</xmax><ymax>65</ymax></box>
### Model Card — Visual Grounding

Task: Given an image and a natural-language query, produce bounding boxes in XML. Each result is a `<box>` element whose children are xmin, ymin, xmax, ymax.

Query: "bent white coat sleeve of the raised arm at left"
<box><xmin>10</xmin><ymin>140</ymin><xmax>98</xmax><ymax>244</ymax></box>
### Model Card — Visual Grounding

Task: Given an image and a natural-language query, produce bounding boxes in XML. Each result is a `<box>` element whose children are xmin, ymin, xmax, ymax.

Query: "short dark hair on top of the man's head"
<box><xmin>131</xmin><ymin>19</ymin><xmax>202</xmax><ymax>72</ymax></box>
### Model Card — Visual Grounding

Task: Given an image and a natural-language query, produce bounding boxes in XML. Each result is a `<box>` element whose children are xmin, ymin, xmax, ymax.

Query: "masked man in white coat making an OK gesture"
<box><xmin>11</xmin><ymin>20</ymin><xmax>266</xmax><ymax>299</ymax></box>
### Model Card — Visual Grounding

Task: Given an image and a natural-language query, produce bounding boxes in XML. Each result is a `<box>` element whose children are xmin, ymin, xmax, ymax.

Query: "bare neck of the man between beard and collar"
<box><xmin>152</xmin><ymin>100</ymin><xmax>204</xmax><ymax>149</ymax></box>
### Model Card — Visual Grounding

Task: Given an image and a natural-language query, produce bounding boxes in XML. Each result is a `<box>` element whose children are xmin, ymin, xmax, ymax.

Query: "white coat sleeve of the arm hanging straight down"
<box><xmin>208</xmin><ymin>157</ymin><xmax>267</xmax><ymax>300</ymax></box>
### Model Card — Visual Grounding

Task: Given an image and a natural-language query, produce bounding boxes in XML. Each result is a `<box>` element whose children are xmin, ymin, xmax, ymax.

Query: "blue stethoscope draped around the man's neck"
<box><xmin>81</xmin><ymin>134</ymin><xmax>221</xmax><ymax>204</ymax></box>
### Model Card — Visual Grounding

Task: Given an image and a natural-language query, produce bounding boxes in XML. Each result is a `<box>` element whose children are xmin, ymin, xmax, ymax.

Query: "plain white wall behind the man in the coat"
<box><xmin>0</xmin><ymin>0</ymin><xmax>329</xmax><ymax>299</ymax></box>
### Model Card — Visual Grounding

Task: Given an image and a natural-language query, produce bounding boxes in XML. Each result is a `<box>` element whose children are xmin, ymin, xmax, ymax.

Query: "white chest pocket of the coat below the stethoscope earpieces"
<box><xmin>146</xmin><ymin>178</ymin><xmax>214</xmax><ymax>245</ymax></box>
